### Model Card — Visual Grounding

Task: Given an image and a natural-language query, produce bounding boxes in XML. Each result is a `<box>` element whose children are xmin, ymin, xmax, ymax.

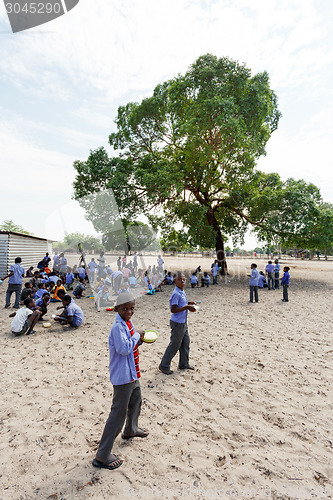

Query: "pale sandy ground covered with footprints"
<box><xmin>0</xmin><ymin>258</ymin><xmax>333</xmax><ymax>500</ymax></box>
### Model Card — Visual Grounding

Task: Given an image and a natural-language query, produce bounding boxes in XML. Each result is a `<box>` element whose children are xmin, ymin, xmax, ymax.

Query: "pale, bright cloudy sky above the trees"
<box><xmin>0</xmin><ymin>0</ymin><xmax>333</xmax><ymax>246</ymax></box>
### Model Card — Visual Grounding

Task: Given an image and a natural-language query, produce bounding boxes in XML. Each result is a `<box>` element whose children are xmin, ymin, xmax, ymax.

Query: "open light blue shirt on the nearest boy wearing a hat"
<box><xmin>109</xmin><ymin>314</ymin><xmax>140</xmax><ymax>385</ymax></box>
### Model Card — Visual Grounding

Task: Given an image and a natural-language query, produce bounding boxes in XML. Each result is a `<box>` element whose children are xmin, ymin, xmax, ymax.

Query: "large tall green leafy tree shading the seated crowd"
<box><xmin>74</xmin><ymin>54</ymin><xmax>280</xmax><ymax>271</ymax></box>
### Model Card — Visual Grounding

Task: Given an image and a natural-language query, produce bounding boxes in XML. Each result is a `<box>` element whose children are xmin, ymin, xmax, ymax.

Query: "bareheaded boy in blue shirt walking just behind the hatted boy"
<box><xmin>159</xmin><ymin>272</ymin><xmax>195</xmax><ymax>375</ymax></box>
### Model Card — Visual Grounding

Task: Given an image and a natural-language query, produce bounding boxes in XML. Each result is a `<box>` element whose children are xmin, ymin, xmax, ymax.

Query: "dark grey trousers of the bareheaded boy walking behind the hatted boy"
<box><xmin>160</xmin><ymin>320</ymin><xmax>190</xmax><ymax>370</ymax></box>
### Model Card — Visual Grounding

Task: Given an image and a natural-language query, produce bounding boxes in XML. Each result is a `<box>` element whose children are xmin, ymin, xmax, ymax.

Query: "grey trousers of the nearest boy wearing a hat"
<box><xmin>96</xmin><ymin>380</ymin><xmax>142</xmax><ymax>461</ymax></box>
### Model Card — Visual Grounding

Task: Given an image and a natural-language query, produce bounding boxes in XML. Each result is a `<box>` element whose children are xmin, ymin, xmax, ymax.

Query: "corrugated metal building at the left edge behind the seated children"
<box><xmin>0</xmin><ymin>231</ymin><xmax>52</xmax><ymax>277</ymax></box>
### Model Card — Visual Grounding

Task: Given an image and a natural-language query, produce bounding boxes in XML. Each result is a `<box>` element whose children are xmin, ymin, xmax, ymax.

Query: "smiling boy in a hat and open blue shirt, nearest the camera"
<box><xmin>92</xmin><ymin>293</ymin><xmax>148</xmax><ymax>470</ymax></box>
